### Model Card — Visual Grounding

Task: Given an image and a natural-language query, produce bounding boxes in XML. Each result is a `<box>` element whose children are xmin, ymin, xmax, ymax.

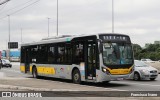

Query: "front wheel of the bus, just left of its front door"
<box><xmin>72</xmin><ymin>69</ymin><xmax>81</xmax><ymax>84</ymax></box>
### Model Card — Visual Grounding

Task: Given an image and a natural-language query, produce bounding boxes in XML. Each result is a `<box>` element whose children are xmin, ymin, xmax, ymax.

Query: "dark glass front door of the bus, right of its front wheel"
<box><xmin>86</xmin><ymin>42</ymin><xmax>96</xmax><ymax>80</ymax></box>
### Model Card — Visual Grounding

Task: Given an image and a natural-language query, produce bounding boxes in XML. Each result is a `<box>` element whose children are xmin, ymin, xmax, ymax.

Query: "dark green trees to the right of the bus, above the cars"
<box><xmin>133</xmin><ymin>44</ymin><xmax>160</xmax><ymax>60</ymax></box>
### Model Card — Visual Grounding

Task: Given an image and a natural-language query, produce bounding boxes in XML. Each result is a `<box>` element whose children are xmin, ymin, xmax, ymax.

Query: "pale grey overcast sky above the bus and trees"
<box><xmin>0</xmin><ymin>0</ymin><xmax>160</xmax><ymax>50</ymax></box>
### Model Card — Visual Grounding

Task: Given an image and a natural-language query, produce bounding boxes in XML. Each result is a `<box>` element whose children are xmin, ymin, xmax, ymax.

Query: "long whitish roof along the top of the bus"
<box><xmin>21</xmin><ymin>33</ymin><xmax>128</xmax><ymax>46</ymax></box>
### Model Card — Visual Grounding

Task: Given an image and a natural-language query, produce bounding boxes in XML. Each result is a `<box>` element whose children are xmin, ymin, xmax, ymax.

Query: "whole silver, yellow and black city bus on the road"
<box><xmin>20</xmin><ymin>33</ymin><xmax>134</xmax><ymax>83</ymax></box>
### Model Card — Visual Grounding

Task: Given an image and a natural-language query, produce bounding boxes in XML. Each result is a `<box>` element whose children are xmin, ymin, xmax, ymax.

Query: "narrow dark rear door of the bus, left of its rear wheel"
<box><xmin>25</xmin><ymin>48</ymin><xmax>30</xmax><ymax>73</ymax></box>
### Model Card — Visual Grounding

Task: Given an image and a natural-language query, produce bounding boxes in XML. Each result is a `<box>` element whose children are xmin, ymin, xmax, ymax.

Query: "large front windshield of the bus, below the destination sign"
<box><xmin>103</xmin><ymin>42</ymin><xmax>133</xmax><ymax>65</ymax></box>
